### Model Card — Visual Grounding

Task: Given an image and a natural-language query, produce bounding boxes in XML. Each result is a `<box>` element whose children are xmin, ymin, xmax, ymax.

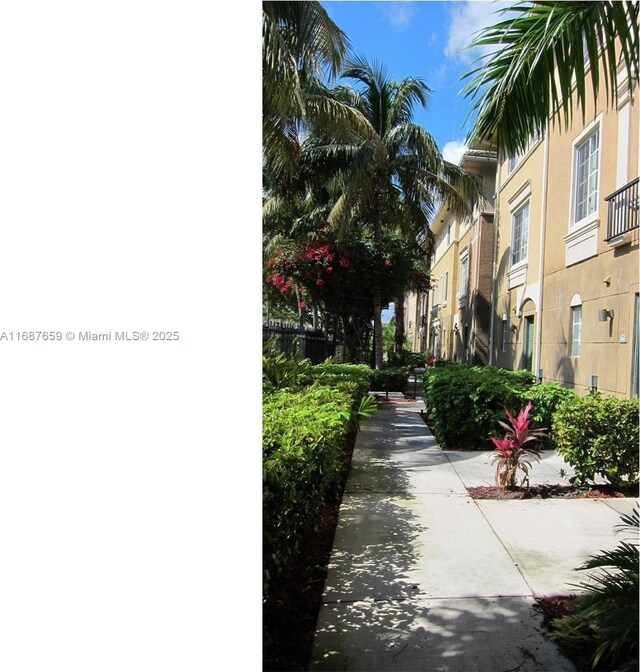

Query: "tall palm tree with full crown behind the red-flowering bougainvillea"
<box><xmin>303</xmin><ymin>58</ymin><xmax>481</xmax><ymax>368</ymax></box>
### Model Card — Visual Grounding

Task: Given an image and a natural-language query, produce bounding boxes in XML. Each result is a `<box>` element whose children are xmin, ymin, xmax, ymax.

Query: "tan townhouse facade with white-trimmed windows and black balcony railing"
<box><xmin>402</xmin><ymin>60</ymin><xmax>640</xmax><ymax>397</ymax></box>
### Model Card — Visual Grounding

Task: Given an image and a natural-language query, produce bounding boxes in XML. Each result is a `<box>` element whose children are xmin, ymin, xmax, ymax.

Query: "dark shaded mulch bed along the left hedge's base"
<box><xmin>262</xmin><ymin>430</ymin><xmax>356</xmax><ymax>672</ymax></box>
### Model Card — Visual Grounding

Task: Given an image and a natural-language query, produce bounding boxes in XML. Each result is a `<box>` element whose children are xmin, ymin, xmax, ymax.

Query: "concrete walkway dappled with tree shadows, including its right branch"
<box><xmin>309</xmin><ymin>395</ymin><xmax>636</xmax><ymax>672</ymax></box>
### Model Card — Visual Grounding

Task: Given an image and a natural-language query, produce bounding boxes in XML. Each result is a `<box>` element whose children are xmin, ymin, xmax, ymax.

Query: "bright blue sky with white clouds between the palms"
<box><xmin>322</xmin><ymin>0</ymin><xmax>510</xmax><ymax>322</ymax></box>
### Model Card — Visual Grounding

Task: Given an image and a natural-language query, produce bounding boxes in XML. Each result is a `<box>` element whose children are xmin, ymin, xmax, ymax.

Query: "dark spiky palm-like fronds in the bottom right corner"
<box><xmin>552</xmin><ymin>507</ymin><xmax>640</xmax><ymax>669</ymax></box>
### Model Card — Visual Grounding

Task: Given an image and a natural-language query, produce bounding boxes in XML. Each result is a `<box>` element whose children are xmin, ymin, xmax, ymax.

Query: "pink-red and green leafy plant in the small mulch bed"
<box><xmin>491</xmin><ymin>402</ymin><xmax>546</xmax><ymax>488</ymax></box>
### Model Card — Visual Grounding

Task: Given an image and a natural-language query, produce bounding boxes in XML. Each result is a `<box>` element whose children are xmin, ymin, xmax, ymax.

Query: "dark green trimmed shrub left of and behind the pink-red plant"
<box><xmin>422</xmin><ymin>364</ymin><xmax>534</xmax><ymax>449</ymax></box>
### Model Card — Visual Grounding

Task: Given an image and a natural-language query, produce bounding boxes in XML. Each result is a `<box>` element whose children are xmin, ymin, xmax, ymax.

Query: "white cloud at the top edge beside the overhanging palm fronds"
<box><xmin>444</xmin><ymin>0</ymin><xmax>513</xmax><ymax>65</ymax></box>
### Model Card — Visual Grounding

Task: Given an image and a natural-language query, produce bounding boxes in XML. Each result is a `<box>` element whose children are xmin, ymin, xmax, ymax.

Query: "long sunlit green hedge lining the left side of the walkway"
<box><xmin>263</xmin><ymin>384</ymin><xmax>353</xmax><ymax>592</ymax></box>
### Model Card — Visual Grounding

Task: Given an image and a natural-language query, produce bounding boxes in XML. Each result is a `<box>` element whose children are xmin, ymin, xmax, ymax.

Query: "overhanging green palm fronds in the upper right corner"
<box><xmin>464</xmin><ymin>1</ymin><xmax>640</xmax><ymax>155</ymax></box>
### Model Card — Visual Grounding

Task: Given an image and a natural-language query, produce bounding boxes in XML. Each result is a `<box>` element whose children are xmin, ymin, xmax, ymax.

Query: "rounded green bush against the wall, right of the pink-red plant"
<box><xmin>552</xmin><ymin>393</ymin><xmax>639</xmax><ymax>487</ymax></box>
